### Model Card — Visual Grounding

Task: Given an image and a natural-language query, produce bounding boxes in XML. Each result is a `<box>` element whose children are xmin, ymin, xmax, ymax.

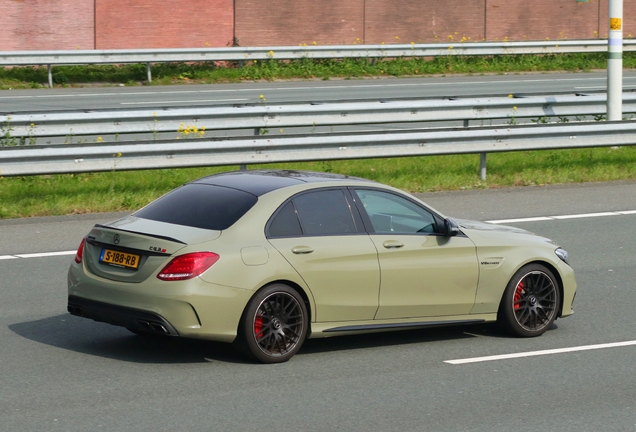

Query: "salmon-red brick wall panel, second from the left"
<box><xmin>94</xmin><ymin>0</ymin><xmax>234</xmax><ymax>49</ymax></box>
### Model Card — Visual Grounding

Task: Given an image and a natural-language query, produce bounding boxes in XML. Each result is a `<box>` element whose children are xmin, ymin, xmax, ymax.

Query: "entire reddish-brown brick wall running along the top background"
<box><xmin>0</xmin><ymin>0</ymin><xmax>636</xmax><ymax>51</ymax></box>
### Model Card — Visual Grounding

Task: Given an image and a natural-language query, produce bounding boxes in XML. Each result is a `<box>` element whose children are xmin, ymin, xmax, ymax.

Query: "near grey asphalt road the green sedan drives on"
<box><xmin>0</xmin><ymin>182</ymin><xmax>636</xmax><ymax>432</ymax></box>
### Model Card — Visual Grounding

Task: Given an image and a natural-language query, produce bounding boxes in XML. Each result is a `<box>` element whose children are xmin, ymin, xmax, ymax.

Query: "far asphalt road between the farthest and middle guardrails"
<box><xmin>0</xmin><ymin>70</ymin><xmax>636</xmax><ymax>113</ymax></box>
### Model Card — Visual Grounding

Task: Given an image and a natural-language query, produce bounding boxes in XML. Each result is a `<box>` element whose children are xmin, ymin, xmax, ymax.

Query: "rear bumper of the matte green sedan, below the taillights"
<box><xmin>68</xmin><ymin>263</ymin><xmax>253</xmax><ymax>342</ymax></box>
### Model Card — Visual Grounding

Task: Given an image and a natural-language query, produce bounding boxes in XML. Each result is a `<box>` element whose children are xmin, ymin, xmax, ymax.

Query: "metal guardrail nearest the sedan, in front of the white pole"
<box><xmin>0</xmin><ymin>122</ymin><xmax>636</xmax><ymax>176</ymax></box>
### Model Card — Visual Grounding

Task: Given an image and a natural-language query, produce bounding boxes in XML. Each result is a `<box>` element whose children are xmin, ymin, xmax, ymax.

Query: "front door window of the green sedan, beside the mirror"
<box><xmin>356</xmin><ymin>189</ymin><xmax>438</xmax><ymax>234</ymax></box>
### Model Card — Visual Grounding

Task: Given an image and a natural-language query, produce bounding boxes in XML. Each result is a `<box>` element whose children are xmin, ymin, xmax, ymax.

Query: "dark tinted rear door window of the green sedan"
<box><xmin>293</xmin><ymin>190</ymin><xmax>356</xmax><ymax>235</ymax></box>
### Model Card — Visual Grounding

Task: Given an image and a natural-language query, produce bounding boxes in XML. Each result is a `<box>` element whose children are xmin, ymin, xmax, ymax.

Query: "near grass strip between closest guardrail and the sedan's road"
<box><xmin>0</xmin><ymin>147</ymin><xmax>636</xmax><ymax>219</ymax></box>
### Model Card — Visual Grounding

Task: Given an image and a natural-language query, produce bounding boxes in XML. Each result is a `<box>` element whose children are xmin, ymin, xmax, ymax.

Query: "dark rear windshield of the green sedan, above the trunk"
<box><xmin>134</xmin><ymin>183</ymin><xmax>258</xmax><ymax>231</ymax></box>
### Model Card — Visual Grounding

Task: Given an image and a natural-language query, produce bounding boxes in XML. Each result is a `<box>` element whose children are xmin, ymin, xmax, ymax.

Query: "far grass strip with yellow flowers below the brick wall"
<box><xmin>0</xmin><ymin>52</ymin><xmax>636</xmax><ymax>89</ymax></box>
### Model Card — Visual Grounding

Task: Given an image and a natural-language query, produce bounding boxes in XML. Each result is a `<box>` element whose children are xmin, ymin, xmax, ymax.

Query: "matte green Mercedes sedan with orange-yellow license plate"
<box><xmin>68</xmin><ymin>170</ymin><xmax>576</xmax><ymax>363</ymax></box>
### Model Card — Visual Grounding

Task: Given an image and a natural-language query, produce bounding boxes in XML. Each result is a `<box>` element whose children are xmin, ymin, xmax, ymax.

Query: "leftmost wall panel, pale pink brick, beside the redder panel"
<box><xmin>0</xmin><ymin>0</ymin><xmax>95</xmax><ymax>51</ymax></box>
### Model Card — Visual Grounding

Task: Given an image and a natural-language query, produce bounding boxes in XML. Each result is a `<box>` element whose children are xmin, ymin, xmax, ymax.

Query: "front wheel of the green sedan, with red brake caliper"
<box><xmin>497</xmin><ymin>264</ymin><xmax>560</xmax><ymax>337</ymax></box>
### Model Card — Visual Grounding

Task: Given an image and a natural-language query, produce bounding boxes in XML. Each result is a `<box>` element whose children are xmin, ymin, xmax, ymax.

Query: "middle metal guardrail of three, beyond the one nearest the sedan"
<box><xmin>0</xmin><ymin>93</ymin><xmax>636</xmax><ymax>141</ymax></box>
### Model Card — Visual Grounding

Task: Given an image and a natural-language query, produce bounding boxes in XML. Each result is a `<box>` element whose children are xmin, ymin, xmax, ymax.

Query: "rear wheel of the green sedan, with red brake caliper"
<box><xmin>238</xmin><ymin>284</ymin><xmax>309</xmax><ymax>363</ymax></box>
